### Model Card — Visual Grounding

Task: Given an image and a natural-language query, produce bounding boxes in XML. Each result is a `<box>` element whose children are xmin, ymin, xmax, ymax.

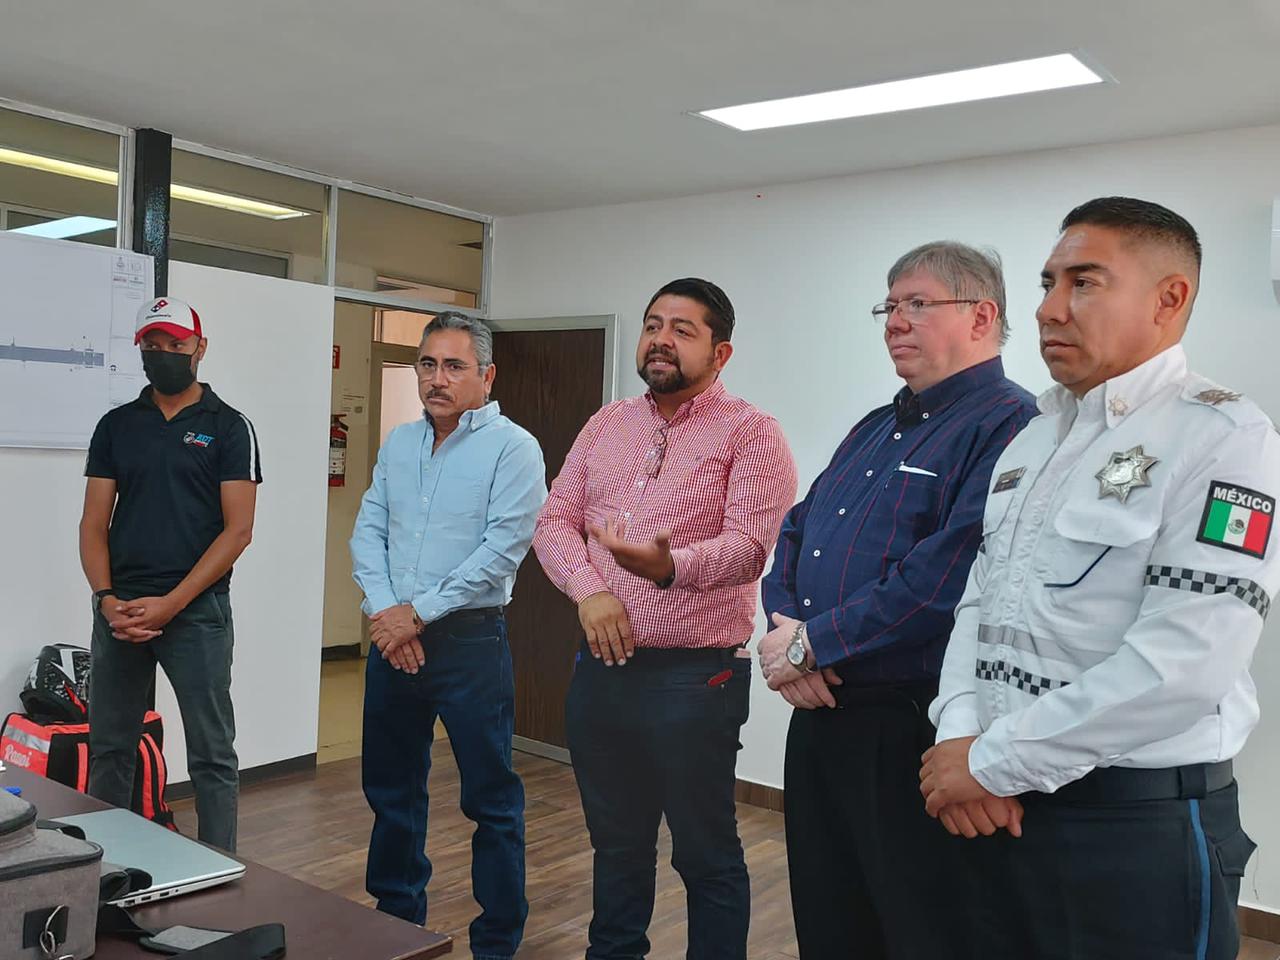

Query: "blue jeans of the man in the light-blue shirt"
<box><xmin>362</xmin><ymin>611</ymin><xmax>529</xmax><ymax>960</ymax></box>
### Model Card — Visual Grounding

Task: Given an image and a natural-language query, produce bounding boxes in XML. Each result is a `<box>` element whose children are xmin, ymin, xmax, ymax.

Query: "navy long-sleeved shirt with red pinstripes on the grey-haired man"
<box><xmin>763</xmin><ymin>357</ymin><xmax>1037</xmax><ymax>686</ymax></box>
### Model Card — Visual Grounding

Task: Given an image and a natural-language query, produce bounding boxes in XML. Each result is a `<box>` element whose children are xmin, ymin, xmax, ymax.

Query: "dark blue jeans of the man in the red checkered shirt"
<box><xmin>564</xmin><ymin>648</ymin><xmax>751</xmax><ymax>960</ymax></box>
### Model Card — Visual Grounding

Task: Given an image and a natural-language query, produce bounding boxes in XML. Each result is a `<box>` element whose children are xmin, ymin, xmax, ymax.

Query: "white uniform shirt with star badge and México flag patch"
<box><xmin>929</xmin><ymin>347</ymin><xmax>1280</xmax><ymax>796</ymax></box>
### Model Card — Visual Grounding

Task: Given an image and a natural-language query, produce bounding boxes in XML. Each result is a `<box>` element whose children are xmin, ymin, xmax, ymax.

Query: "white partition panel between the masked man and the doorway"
<box><xmin>156</xmin><ymin>264</ymin><xmax>333</xmax><ymax>781</ymax></box>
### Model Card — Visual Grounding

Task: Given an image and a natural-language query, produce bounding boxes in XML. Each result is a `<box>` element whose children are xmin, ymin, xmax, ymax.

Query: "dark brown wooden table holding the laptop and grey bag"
<box><xmin>0</xmin><ymin>765</ymin><xmax>453</xmax><ymax>960</ymax></box>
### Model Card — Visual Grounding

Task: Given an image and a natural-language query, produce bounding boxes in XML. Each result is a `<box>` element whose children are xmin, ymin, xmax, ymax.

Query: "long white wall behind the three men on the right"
<box><xmin>493</xmin><ymin>127</ymin><xmax>1280</xmax><ymax>906</ymax></box>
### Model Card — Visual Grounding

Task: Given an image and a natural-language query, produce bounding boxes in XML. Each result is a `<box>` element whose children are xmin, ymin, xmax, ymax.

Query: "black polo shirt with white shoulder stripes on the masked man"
<box><xmin>84</xmin><ymin>384</ymin><xmax>262</xmax><ymax>600</ymax></box>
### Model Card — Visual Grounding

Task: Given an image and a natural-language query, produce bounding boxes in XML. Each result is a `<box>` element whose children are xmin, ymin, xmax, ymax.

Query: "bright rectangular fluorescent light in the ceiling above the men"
<box><xmin>698</xmin><ymin>54</ymin><xmax>1103</xmax><ymax>131</ymax></box>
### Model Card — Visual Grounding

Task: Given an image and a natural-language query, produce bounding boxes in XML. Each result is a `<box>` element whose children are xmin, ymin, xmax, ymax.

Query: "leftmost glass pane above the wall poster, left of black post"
<box><xmin>0</xmin><ymin>109</ymin><xmax>120</xmax><ymax>247</ymax></box>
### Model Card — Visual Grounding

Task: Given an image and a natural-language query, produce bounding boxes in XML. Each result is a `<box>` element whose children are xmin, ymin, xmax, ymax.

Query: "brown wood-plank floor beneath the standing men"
<box><xmin>174</xmin><ymin>741</ymin><xmax>1280</xmax><ymax>960</ymax></box>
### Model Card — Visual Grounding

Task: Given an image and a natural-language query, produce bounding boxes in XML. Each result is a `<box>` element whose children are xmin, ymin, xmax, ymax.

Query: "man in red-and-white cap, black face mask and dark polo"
<box><xmin>79</xmin><ymin>297</ymin><xmax>262</xmax><ymax>850</ymax></box>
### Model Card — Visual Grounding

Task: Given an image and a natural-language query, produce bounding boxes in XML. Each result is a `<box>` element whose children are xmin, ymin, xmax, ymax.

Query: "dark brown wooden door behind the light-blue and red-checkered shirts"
<box><xmin>493</xmin><ymin>329</ymin><xmax>605</xmax><ymax>755</ymax></box>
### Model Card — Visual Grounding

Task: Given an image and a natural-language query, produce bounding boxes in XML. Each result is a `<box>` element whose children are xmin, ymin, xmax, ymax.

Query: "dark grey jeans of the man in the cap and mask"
<box><xmin>88</xmin><ymin>593</ymin><xmax>239</xmax><ymax>851</ymax></box>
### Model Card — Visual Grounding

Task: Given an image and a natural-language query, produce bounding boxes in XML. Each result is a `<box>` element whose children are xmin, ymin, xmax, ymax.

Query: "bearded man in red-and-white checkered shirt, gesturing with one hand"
<box><xmin>534</xmin><ymin>273</ymin><xmax>796</xmax><ymax>960</ymax></box>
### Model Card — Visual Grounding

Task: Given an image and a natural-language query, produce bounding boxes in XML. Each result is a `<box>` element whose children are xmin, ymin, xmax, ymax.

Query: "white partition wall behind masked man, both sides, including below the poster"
<box><xmin>0</xmin><ymin>257</ymin><xmax>333</xmax><ymax>782</ymax></box>
